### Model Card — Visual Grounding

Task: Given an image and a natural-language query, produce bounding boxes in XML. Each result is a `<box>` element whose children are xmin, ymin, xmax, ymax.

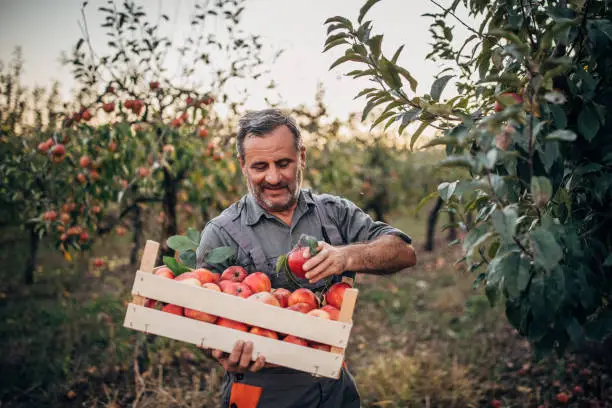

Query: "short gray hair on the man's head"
<box><xmin>236</xmin><ymin>109</ymin><xmax>302</xmax><ymax>160</ymax></box>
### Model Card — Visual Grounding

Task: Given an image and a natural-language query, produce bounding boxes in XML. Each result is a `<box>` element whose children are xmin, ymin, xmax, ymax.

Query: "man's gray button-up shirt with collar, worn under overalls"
<box><xmin>196</xmin><ymin>190</ymin><xmax>412</xmax><ymax>288</ymax></box>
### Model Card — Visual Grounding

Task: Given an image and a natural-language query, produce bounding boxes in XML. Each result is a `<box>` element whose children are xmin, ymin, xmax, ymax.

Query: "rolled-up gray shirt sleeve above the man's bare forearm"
<box><xmin>332</xmin><ymin>198</ymin><xmax>412</xmax><ymax>244</ymax></box>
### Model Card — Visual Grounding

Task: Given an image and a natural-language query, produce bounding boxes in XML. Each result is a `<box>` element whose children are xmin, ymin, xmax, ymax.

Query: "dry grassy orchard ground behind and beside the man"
<box><xmin>0</xmin><ymin>210</ymin><xmax>612</xmax><ymax>407</ymax></box>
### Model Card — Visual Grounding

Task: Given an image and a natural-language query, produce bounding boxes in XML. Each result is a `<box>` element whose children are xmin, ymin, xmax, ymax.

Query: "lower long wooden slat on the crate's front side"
<box><xmin>125</xmin><ymin>303</ymin><xmax>343</xmax><ymax>378</ymax></box>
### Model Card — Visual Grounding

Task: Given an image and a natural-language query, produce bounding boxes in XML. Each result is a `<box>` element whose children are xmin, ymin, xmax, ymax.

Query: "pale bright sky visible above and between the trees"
<box><xmin>0</xmin><ymin>0</ymin><xmax>468</xmax><ymax>126</ymax></box>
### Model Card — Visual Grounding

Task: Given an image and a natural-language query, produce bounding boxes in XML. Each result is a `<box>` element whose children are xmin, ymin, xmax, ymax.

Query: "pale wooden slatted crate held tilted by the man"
<box><xmin>123</xmin><ymin>241</ymin><xmax>358</xmax><ymax>378</ymax></box>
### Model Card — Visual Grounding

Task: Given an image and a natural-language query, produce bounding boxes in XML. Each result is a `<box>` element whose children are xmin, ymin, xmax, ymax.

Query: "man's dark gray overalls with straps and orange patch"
<box><xmin>203</xmin><ymin>192</ymin><xmax>360</xmax><ymax>408</ymax></box>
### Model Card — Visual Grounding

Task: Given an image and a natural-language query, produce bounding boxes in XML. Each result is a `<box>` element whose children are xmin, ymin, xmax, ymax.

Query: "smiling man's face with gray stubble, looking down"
<box><xmin>240</xmin><ymin>126</ymin><xmax>306</xmax><ymax>212</ymax></box>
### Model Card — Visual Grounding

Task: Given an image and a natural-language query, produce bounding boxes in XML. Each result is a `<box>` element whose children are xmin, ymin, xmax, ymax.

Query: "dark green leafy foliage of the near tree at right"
<box><xmin>325</xmin><ymin>0</ymin><xmax>612</xmax><ymax>352</ymax></box>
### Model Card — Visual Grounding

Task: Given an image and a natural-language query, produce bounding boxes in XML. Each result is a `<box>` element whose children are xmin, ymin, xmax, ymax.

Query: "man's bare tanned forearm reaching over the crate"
<box><xmin>342</xmin><ymin>235</ymin><xmax>416</xmax><ymax>275</ymax></box>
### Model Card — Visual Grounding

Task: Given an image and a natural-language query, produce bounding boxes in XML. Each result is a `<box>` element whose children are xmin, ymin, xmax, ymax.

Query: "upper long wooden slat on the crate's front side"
<box><xmin>132</xmin><ymin>271</ymin><xmax>352</xmax><ymax>347</ymax></box>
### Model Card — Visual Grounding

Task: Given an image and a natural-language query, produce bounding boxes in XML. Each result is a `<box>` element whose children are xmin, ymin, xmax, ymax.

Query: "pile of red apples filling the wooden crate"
<box><xmin>145</xmin><ymin>266</ymin><xmax>350</xmax><ymax>351</ymax></box>
